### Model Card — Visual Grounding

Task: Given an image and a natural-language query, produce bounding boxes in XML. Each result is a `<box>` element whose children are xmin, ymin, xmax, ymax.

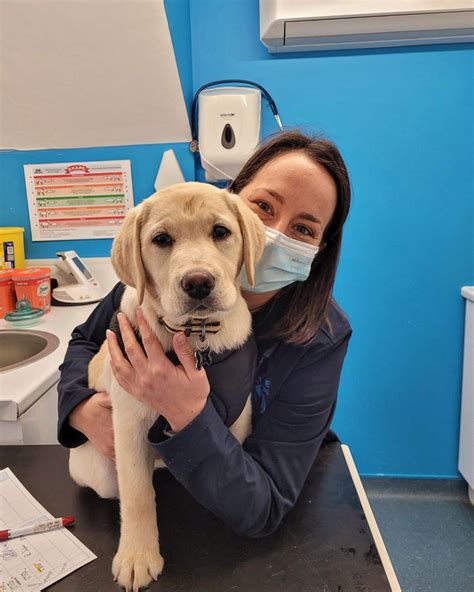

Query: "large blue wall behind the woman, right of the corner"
<box><xmin>191</xmin><ymin>0</ymin><xmax>474</xmax><ymax>476</ymax></box>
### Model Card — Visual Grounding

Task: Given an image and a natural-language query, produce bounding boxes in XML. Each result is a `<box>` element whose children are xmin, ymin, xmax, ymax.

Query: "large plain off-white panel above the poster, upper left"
<box><xmin>0</xmin><ymin>0</ymin><xmax>191</xmax><ymax>150</ymax></box>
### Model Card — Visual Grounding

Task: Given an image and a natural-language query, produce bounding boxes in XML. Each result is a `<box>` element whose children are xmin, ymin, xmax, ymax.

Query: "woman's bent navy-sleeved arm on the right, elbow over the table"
<box><xmin>149</xmin><ymin>335</ymin><xmax>349</xmax><ymax>537</ymax></box>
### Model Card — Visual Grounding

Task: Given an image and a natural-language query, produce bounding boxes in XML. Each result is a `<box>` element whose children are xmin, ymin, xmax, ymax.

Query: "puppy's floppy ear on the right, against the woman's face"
<box><xmin>224</xmin><ymin>190</ymin><xmax>265</xmax><ymax>286</ymax></box>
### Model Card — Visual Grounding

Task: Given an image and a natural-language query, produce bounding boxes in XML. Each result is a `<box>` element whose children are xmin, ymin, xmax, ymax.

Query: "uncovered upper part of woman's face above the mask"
<box><xmin>239</xmin><ymin>152</ymin><xmax>337</xmax><ymax>245</ymax></box>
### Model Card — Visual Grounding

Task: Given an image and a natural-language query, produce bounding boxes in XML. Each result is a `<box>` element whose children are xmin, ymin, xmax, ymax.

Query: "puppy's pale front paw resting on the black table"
<box><xmin>112</xmin><ymin>542</ymin><xmax>163</xmax><ymax>592</ymax></box>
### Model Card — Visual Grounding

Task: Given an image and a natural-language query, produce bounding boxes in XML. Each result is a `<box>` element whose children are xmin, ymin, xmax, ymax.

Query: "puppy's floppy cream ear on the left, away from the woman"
<box><xmin>111</xmin><ymin>204</ymin><xmax>147</xmax><ymax>304</ymax></box>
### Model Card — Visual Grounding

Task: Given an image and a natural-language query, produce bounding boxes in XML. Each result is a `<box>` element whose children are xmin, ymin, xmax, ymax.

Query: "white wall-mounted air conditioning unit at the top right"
<box><xmin>260</xmin><ymin>0</ymin><xmax>474</xmax><ymax>53</ymax></box>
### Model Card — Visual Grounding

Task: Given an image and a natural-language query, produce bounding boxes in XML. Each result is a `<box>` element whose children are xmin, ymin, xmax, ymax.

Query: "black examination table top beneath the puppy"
<box><xmin>0</xmin><ymin>442</ymin><xmax>391</xmax><ymax>592</ymax></box>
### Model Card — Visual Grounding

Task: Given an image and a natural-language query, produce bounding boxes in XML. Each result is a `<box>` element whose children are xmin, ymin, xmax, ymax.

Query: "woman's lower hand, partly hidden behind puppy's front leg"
<box><xmin>69</xmin><ymin>393</ymin><xmax>115</xmax><ymax>460</ymax></box>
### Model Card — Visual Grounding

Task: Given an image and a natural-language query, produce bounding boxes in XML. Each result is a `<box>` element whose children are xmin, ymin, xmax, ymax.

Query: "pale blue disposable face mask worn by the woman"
<box><xmin>240</xmin><ymin>226</ymin><xmax>319</xmax><ymax>293</ymax></box>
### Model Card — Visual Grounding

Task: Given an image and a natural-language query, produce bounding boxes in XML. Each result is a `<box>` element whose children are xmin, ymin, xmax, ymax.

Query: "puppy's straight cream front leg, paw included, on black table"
<box><xmin>112</xmin><ymin>385</ymin><xmax>163</xmax><ymax>591</ymax></box>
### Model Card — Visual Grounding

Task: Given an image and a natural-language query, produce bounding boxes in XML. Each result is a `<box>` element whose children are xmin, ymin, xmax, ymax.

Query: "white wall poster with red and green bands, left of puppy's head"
<box><xmin>24</xmin><ymin>160</ymin><xmax>133</xmax><ymax>241</ymax></box>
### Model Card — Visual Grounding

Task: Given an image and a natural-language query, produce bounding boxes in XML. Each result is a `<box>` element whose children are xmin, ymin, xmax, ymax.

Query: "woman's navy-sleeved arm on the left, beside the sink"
<box><xmin>58</xmin><ymin>283</ymin><xmax>125</xmax><ymax>448</ymax></box>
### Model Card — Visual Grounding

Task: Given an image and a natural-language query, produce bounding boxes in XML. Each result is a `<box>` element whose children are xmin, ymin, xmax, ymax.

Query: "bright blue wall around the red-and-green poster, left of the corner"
<box><xmin>0</xmin><ymin>0</ymin><xmax>194</xmax><ymax>259</ymax></box>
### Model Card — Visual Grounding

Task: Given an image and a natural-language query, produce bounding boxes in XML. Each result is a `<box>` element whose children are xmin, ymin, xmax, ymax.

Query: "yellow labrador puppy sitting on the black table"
<box><xmin>69</xmin><ymin>183</ymin><xmax>265</xmax><ymax>590</ymax></box>
